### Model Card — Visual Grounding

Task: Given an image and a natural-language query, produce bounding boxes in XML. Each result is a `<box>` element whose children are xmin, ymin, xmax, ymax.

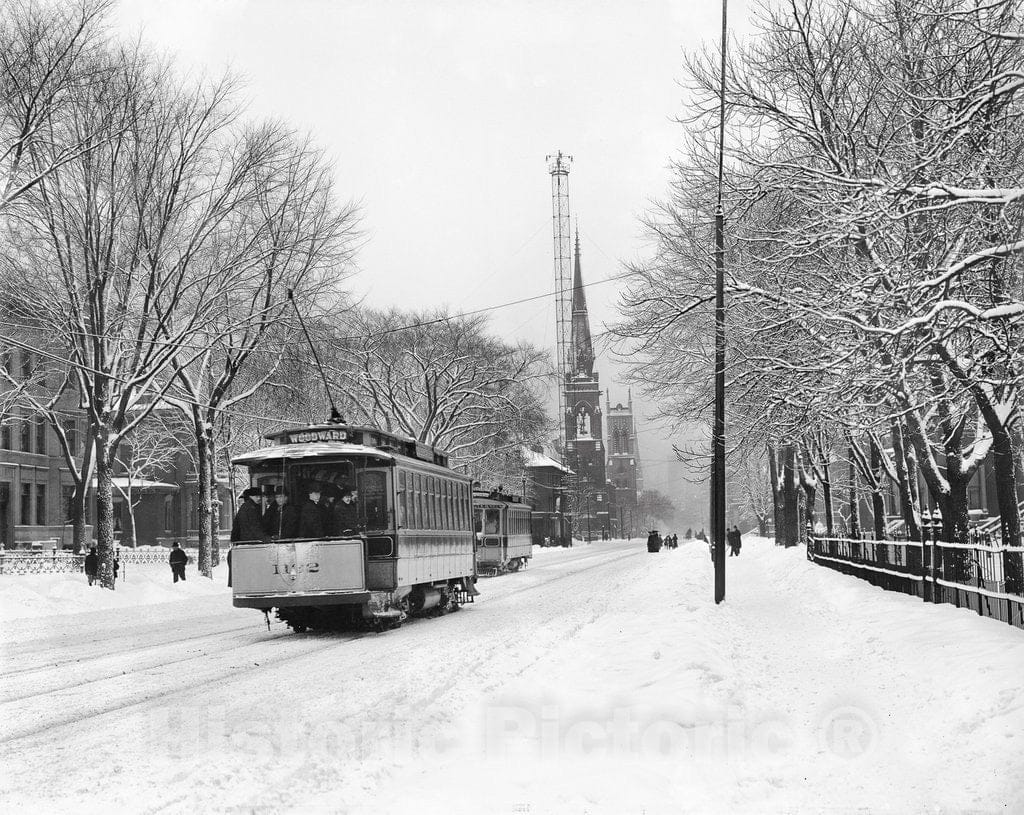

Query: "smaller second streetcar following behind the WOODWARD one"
<box><xmin>473</xmin><ymin>489</ymin><xmax>534</xmax><ymax>576</ymax></box>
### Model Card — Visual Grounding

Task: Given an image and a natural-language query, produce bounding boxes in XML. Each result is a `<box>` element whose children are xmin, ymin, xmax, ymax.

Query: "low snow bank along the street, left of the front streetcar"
<box><xmin>0</xmin><ymin>563</ymin><xmax>230</xmax><ymax>620</ymax></box>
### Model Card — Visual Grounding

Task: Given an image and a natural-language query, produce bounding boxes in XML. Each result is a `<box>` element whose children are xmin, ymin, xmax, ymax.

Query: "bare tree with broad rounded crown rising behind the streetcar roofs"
<box><xmin>332</xmin><ymin>309</ymin><xmax>549</xmax><ymax>483</ymax></box>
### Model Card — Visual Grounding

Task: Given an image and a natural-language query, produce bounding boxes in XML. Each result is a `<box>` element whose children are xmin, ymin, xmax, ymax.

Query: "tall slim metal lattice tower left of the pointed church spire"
<box><xmin>548</xmin><ymin>152</ymin><xmax>572</xmax><ymax>454</ymax></box>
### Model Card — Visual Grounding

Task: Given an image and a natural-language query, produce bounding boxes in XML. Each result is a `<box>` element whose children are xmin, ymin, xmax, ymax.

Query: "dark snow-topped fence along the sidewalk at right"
<box><xmin>807</xmin><ymin>538</ymin><xmax>1024</xmax><ymax>629</ymax></box>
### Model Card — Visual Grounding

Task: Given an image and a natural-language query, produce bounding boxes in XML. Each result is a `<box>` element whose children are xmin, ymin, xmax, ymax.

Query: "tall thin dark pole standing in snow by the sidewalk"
<box><xmin>712</xmin><ymin>0</ymin><xmax>728</xmax><ymax>604</ymax></box>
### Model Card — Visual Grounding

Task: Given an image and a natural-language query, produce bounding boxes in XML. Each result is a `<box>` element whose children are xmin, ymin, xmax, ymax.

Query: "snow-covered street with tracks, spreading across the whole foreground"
<box><xmin>0</xmin><ymin>538</ymin><xmax>1024</xmax><ymax>815</ymax></box>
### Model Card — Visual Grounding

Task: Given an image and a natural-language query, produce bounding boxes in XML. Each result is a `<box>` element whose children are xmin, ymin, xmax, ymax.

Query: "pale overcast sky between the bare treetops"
<box><xmin>117</xmin><ymin>0</ymin><xmax>746</xmax><ymax>523</ymax></box>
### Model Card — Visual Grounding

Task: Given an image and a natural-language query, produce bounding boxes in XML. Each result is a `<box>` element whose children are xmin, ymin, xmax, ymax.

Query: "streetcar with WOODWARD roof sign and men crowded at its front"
<box><xmin>231</xmin><ymin>423</ymin><xmax>477</xmax><ymax>632</ymax></box>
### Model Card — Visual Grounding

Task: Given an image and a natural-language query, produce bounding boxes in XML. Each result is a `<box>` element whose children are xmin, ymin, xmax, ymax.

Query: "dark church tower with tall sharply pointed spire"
<box><xmin>562</xmin><ymin>230</ymin><xmax>612</xmax><ymax>538</ymax></box>
